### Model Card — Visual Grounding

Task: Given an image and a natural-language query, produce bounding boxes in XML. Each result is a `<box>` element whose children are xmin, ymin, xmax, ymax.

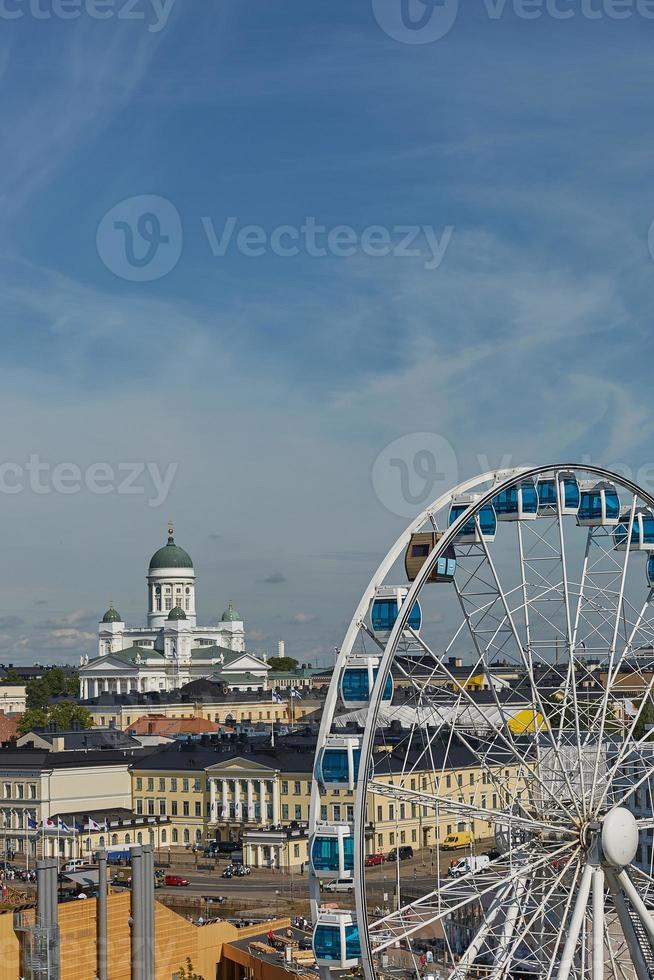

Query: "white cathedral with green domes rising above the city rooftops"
<box><xmin>79</xmin><ymin>526</ymin><xmax>269</xmax><ymax>700</ymax></box>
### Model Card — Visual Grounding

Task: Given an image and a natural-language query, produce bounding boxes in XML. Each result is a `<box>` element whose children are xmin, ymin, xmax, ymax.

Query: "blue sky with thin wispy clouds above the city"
<box><xmin>0</xmin><ymin>0</ymin><xmax>654</xmax><ymax>662</ymax></box>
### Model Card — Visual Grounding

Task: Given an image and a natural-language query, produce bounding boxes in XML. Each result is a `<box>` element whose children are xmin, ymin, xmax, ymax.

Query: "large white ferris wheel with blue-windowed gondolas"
<box><xmin>310</xmin><ymin>464</ymin><xmax>654</xmax><ymax>980</ymax></box>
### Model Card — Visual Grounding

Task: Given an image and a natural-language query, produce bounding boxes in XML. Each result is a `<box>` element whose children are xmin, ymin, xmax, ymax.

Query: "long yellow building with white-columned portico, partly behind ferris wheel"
<box><xmin>132</xmin><ymin>735</ymin><xmax>526</xmax><ymax>869</ymax></box>
